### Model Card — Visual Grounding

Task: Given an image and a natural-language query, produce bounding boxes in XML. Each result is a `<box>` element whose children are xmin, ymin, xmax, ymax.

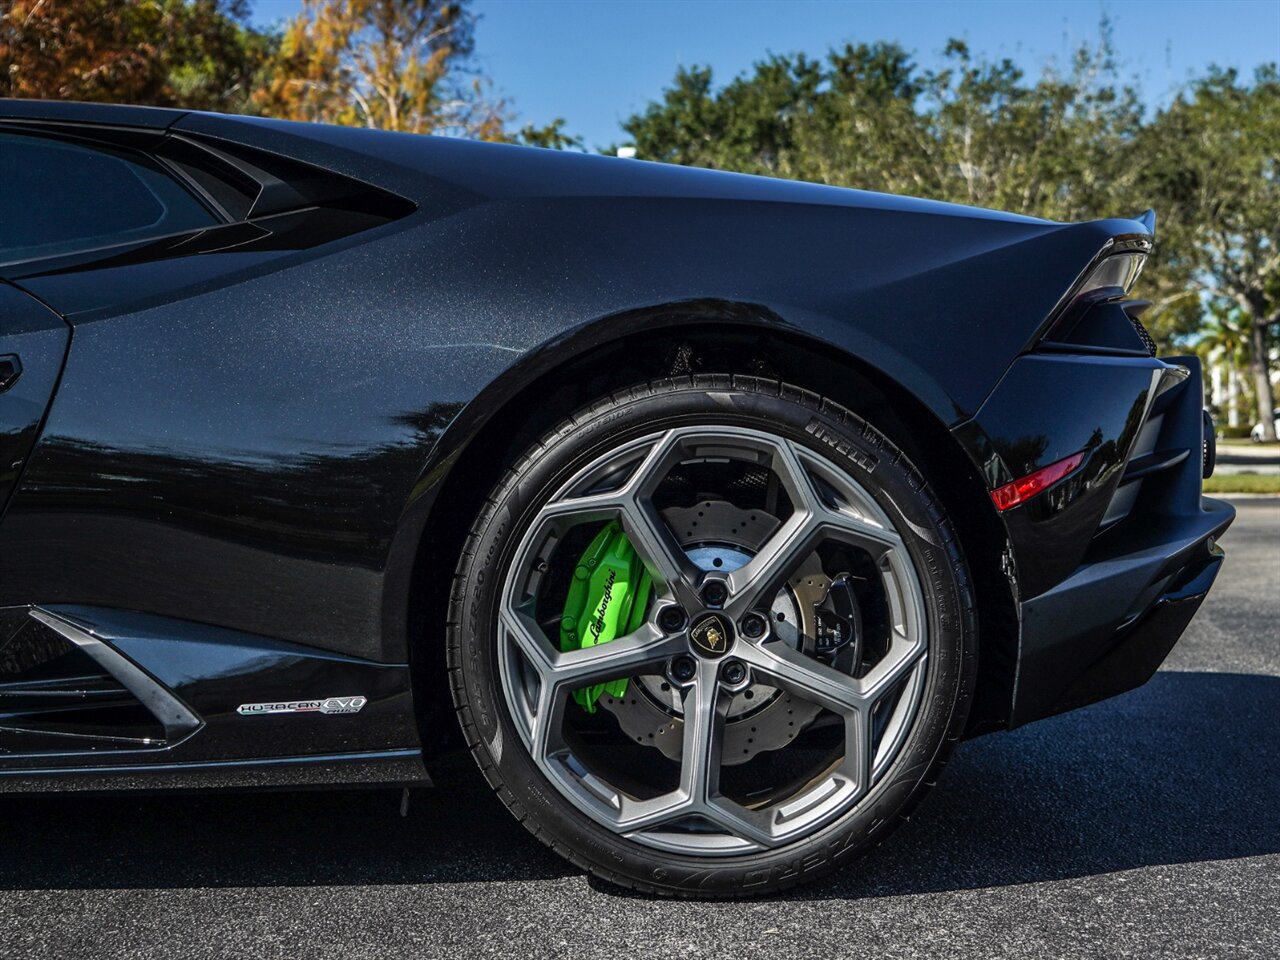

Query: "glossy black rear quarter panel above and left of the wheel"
<box><xmin>0</xmin><ymin>106</ymin><xmax>1141</xmax><ymax>660</ymax></box>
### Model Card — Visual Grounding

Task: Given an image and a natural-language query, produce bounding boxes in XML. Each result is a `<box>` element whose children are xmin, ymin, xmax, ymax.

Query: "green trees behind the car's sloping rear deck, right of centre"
<box><xmin>622</xmin><ymin>24</ymin><xmax>1142</xmax><ymax>219</ymax></box>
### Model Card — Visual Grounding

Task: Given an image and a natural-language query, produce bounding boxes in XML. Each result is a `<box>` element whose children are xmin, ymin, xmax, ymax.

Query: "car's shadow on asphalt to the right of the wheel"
<box><xmin>795</xmin><ymin>672</ymin><xmax>1280</xmax><ymax>899</ymax></box>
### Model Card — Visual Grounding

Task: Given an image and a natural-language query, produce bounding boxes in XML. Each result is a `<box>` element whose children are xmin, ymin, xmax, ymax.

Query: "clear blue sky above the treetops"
<box><xmin>253</xmin><ymin>0</ymin><xmax>1280</xmax><ymax>147</ymax></box>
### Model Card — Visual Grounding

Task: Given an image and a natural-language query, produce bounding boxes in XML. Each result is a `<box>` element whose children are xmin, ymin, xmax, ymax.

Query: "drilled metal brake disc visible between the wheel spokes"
<box><xmin>599</xmin><ymin>500</ymin><xmax>831</xmax><ymax>765</ymax></box>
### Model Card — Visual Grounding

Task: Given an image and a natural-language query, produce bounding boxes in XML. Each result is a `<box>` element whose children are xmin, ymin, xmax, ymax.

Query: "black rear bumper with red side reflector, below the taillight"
<box><xmin>979</xmin><ymin>356</ymin><xmax>1235</xmax><ymax>726</ymax></box>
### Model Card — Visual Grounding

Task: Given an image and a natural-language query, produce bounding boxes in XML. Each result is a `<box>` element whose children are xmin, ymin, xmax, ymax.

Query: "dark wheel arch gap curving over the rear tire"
<box><xmin>392</xmin><ymin>301</ymin><xmax>1018</xmax><ymax>754</ymax></box>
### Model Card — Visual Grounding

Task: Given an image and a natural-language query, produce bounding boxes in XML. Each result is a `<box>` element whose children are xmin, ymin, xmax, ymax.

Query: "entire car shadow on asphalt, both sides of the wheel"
<box><xmin>0</xmin><ymin>672</ymin><xmax>1280</xmax><ymax>900</ymax></box>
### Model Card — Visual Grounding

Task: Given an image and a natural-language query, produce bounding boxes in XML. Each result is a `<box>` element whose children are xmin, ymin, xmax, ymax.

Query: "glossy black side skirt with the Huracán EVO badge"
<box><xmin>0</xmin><ymin>605</ymin><xmax>426</xmax><ymax>792</ymax></box>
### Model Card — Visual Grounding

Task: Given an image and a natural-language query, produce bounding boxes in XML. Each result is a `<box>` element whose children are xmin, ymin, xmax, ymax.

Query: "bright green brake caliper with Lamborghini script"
<box><xmin>561</xmin><ymin>521</ymin><xmax>653</xmax><ymax>713</ymax></box>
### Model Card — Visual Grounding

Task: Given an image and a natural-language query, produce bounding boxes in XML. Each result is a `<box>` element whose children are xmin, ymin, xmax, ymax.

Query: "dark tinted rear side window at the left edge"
<box><xmin>0</xmin><ymin>133</ymin><xmax>220</xmax><ymax>265</ymax></box>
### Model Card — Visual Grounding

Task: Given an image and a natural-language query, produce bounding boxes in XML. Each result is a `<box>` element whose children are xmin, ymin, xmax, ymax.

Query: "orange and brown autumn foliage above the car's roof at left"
<box><xmin>0</xmin><ymin>0</ymin><xmax>563</xmax><ymax>148</ymax></box>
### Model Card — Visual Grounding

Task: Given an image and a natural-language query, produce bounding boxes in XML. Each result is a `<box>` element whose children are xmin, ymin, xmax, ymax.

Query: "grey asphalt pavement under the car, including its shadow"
<box><xmin>0</xmin><ymin>499</ymin><xmax>1280</xmax><ymax>960</ymax></box>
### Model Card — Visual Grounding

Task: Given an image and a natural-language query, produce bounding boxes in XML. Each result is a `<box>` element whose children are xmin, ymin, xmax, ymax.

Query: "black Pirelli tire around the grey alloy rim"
<box><xmin>448</xmin><ymin>375</ymin><xmax>978</xmax><ymax>899</ymax></box>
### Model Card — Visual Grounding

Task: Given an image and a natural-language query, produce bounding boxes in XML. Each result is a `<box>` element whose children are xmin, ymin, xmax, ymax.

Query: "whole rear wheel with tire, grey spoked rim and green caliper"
<box><xmin>448</xmin><ymin>375</ymin><xmax>977</xmax><ymax>896</ymax></box>
